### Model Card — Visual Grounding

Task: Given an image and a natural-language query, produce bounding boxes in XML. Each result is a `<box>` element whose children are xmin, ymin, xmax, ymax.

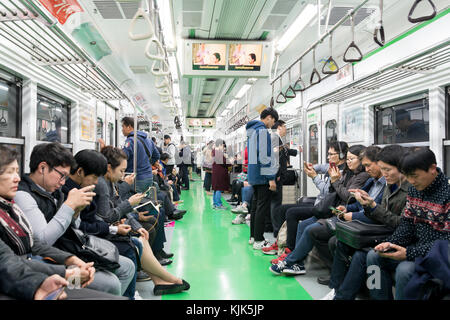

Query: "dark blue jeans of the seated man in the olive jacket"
<box><xmin>329</xmin><ymin>241</ymin><xmax>367</xmax><ymax>300</ymax></box>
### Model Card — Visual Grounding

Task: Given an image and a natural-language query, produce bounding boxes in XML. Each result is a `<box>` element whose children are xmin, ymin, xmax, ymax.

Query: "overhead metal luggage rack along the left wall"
<box><xmin>0</xmin><ymin>0</ymin><xmax>126</xmax><ymax>101</ymax></box>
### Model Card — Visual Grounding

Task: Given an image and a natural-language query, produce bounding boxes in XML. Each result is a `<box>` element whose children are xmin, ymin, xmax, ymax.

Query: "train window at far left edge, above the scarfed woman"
<box><xmin>0</xmin><ymin>80</ymin><xmax>20</xmax><ymax>138</ymax></box>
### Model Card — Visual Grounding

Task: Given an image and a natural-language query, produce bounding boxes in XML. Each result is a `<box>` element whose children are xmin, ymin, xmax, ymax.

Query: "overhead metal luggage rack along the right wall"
<box><xmin>312</xmin><ymin>40</ymin><xmax>450</xmax><ymax>103</ymax></box>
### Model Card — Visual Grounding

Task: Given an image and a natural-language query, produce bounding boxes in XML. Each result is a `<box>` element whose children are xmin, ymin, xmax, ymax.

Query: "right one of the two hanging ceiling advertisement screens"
<box><xmin>228</xmin><ymin>43</ymin><xmax>262</xmax><ymax>71</ymax></box>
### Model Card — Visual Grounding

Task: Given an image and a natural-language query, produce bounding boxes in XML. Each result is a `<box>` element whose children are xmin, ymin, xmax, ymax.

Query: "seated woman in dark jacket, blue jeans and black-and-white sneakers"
<box><xmin>269</xmin><ymin>145</ymin><xmax>369</xmax><ymax>275</ymax></box>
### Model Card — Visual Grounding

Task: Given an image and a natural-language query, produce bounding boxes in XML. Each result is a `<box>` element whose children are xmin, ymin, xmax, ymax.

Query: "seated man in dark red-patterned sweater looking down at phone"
<box><xmin>367</xmin><ymin>148</ymin><xmax>450</xmax><ymax>300</ymax></box>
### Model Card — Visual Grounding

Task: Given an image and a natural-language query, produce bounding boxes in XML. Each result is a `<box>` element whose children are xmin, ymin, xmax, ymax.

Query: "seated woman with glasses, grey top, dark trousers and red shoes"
<box><xmin>268</xmin><ymin>141</ymin><xmax>348</xmax><ymax>264</ymax></box>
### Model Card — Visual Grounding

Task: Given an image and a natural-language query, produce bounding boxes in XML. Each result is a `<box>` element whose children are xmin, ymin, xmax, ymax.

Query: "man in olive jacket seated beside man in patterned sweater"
<box><xmin>324</xmin><ymin>145</ymin><xmax>411</xmax><ymax>300</ymax></box>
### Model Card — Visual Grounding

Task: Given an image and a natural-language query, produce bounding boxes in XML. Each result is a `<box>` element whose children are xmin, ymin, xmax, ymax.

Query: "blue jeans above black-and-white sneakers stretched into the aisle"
<box><xmin>285</xmin><ymin>217</ymin><xmax>319</xmax><ymax>265</ymax></box>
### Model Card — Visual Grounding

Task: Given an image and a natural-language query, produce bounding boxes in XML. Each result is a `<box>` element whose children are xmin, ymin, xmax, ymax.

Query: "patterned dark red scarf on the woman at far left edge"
<box><xmin>0</xmin><ymin>197</ymin><xmax>33</xmax><ymax>256</ymax></box>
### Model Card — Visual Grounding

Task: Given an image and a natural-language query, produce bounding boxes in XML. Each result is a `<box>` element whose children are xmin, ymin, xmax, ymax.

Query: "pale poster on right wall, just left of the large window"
<box><xmin>341</xmin><ymin>107</ymin><xmax>365</xmax><ymax>142</ymax></box>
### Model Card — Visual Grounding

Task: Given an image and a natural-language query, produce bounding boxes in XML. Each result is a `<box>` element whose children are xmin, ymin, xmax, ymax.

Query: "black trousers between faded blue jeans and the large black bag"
<box><xmin>309</xmin><ymin>220</ymin><xmax>337</xmax><ymax>270</ymax></box>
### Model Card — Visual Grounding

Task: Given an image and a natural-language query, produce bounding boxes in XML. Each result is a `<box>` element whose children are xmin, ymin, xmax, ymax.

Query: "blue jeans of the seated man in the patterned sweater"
<box><xmin>367</xmin><ymin>250</ymin><xmax>415</xmax><ymax>300</ymax></box>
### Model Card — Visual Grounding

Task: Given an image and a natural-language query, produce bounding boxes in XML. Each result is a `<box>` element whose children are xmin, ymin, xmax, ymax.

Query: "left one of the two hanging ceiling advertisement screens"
<box><xmin>192</xmin><ymin>43</ymin><xmax>227</xmax><ymax>70</ymax></box>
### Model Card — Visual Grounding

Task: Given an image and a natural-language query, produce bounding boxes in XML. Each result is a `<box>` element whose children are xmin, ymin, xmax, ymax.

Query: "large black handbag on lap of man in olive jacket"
<box><xmin>336</xmin><ymin>220</ymin><xmax>394</xmax><ymax>250</ymax></box>
